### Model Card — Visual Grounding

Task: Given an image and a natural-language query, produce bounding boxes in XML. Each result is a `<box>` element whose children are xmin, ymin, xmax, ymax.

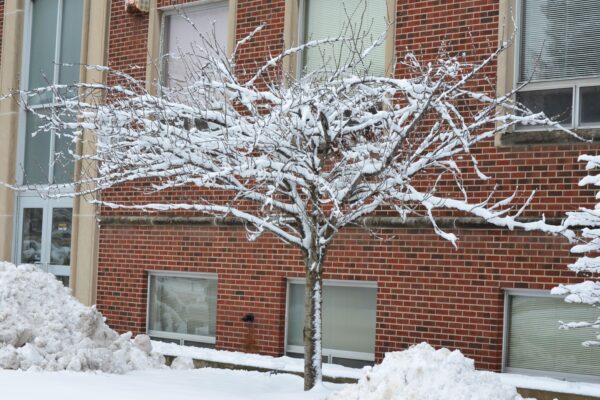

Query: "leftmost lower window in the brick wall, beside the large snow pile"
<box><xmin>147</xmin><ymin>272</ymin><xmax>217</xmax><ymax>347</ymax></box>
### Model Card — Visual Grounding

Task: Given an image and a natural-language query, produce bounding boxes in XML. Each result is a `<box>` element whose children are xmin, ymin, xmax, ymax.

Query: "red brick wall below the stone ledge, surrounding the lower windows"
<box><xmin>98</xmin><ymin>225</ymin><xmax>572</xmax><ymax>369</ymax></box>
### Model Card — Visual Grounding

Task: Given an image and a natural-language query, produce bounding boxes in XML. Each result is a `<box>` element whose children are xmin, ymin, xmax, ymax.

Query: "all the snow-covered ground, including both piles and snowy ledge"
<box><xmin>0</xmin><ymin>262</ymin><xmax>600</xmax><ymax>400</ymax></box>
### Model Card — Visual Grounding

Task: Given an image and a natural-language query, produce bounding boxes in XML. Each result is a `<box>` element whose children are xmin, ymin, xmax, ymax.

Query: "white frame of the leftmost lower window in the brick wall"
<box><xmin>146</xmin><ymin>270</ymin><xmax>219</xmax><ymax>346</ymax></box>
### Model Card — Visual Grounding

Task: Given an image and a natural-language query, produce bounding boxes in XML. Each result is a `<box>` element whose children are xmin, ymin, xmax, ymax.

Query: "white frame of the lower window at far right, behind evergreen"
<box><xmin>502</xmin><ymin>288</ymin><xmax>600</xmax><ymax>382</ymax></box>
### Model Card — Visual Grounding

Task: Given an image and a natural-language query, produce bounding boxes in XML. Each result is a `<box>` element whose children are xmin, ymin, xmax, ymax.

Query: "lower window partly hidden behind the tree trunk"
<box><xmin>286</xmin><ymin>279</ymin><xmax>377</xmax><ymax>367</ymax></box>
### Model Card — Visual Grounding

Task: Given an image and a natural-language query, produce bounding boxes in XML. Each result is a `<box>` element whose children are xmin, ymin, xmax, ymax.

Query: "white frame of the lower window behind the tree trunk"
<box><xmin>284</xmin><ymin>278</ymin><xmax>377</xmax><ymax>364</ymax></box>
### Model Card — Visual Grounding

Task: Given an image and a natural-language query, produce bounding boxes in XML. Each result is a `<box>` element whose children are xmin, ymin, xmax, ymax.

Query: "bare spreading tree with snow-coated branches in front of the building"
<box><xmin>11</xmin><ymin>23</ymin><xmax>572</xmax><ymax>389</ymax></box>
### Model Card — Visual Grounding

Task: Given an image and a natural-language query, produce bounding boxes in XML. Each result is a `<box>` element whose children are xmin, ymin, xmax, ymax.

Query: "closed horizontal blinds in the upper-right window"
<box><xmin>519</xmin><ymin>0</ymin><xmax>600</xmax><ymax>82</ymax></box>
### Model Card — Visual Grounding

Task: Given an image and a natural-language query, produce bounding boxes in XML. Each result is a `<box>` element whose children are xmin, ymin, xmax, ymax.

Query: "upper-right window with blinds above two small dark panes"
<box><xmin>515</xmin><ymin>0</ymin><xmax>600</xmax><ymax>130</ymax></box>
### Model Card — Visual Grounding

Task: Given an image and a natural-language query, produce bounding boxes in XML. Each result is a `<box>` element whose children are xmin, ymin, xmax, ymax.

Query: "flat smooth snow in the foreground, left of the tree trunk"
<box><xmin>0</xmin><ymin>368</ymin><xmax>343</xmax><ymax>400</ymax></box>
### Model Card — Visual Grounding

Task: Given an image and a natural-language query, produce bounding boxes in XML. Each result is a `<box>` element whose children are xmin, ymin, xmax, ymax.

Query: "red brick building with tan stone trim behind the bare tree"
<box><xmin>0</xmin><ymin>0</ymin><xmax>600</xmax><ymax>380</ymax></box>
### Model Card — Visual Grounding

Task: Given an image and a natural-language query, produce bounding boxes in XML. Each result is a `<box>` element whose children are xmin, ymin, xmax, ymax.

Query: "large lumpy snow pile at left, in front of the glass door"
<box><xmin>0</xmin><ymin>262</ymin><xmax>163</xmax><ymax>373</ymax></box>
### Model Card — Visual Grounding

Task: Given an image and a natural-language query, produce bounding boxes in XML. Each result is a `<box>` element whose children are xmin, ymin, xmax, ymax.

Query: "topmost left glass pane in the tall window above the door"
<box><xmin>29</xmin><ymin>0</ymin><xmax>58</xmax><ymax>103</ymax></box>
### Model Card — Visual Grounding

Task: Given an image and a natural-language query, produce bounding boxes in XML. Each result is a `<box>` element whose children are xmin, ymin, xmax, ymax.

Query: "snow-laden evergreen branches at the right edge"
<box><xmin>552</xmin><ymin>155</ymin><xmax>600</xmax><ymax>347</ymax></box>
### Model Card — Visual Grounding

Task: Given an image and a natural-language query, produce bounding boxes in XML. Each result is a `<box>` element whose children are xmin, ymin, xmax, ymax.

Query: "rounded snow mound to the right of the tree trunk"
<box><xmin>327</xmin><ymin>343</ymin><xmax>522</xmax><ymax>400</ymax></box>
